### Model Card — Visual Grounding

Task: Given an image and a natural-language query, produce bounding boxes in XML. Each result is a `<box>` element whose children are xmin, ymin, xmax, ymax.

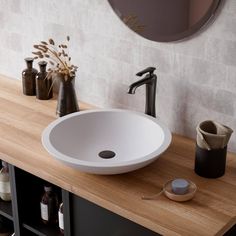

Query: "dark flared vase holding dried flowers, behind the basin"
<box><xmin>56</xmin><ymin>75</ymin><xmax>79</xmax><ymax>117</ymax></box>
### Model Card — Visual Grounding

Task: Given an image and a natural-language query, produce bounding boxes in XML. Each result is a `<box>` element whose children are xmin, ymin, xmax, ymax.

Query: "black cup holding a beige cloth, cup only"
<box><xmin>194</xmin><ymin>144</ymin><xmax>227</xmax><ymax>178</ymax></box>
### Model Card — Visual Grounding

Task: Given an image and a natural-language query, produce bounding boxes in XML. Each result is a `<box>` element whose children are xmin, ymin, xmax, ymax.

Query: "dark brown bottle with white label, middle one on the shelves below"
<box><xmin>40</xmin><ymin>186</ymin><xmax>59</xmax><ymax>225</ymax></box>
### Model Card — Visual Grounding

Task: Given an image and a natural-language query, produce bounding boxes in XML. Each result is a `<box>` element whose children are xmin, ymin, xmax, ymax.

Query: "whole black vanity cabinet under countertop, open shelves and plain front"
<box><xmin>0</xmin><ymin>160</ymin><xmax>236</xmax><ymax>236</ymax></box>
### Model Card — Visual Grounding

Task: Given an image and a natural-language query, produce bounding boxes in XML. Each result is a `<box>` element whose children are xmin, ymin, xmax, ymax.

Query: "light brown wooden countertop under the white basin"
<box><xmin>0</xmin><ymin>76</ymin><xmax>236</xmax><ymax>236</ymax></box>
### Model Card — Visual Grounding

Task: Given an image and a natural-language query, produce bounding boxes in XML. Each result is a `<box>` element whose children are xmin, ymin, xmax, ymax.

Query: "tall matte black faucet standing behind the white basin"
<box><xmin>128</xmin><ymin>67</ymin><xmax>157</xmax><ymax>117</ymax></box>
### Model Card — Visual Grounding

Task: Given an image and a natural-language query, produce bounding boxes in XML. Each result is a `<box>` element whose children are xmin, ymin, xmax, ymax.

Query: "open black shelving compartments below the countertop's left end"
<box><xmin>0</xmin><ymin>160</ymin><xmax>71</xmax><ymax>236</ymax></box>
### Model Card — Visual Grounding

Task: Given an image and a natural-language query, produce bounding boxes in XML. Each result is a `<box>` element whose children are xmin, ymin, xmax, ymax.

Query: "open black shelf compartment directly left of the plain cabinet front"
<box><xmin>11</xmin><ymin>167</ymin><xmax>69</xmax><ymax>236</ymax></box>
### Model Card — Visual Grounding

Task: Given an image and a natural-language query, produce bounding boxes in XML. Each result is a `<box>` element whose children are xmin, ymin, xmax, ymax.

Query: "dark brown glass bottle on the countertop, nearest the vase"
<box><xmin>36</xmin><ymin>61</ymin><xmax>53</xmax><ymax>100</ymax></box>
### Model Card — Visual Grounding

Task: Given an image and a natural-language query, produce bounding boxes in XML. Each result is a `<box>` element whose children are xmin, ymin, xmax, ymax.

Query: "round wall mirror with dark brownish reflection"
<box><xmin>108</xmin><ymin>0</ymin><xmax>222</xmax><ymax>42</ymax></box>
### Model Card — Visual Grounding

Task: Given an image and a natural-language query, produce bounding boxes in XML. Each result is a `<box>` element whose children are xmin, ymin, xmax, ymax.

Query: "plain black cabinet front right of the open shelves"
<box><xmin>70</xmin><ymin>195</ymin><xmax>159</xmax><ymax>236</ymax></box>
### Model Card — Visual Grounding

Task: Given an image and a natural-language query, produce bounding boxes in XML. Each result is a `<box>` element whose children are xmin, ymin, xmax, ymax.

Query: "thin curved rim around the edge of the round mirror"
<box><xmin>108</xmin><ymin>0</ymin><xmax>224</xmax><ymax>42</ymax></box>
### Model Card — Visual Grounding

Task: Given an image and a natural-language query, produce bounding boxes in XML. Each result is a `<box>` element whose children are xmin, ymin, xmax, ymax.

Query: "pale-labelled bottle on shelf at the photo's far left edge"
<box><xmin>0</xmin><ymin>161</ymin><xmax>11</xmax><ymax>201</ymax></box>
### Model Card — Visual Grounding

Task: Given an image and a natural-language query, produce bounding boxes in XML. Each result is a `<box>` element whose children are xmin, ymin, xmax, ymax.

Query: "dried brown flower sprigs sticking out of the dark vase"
<box><xmin>32</xmin><ymin>36</ymin><xmax>78</xmax><ymax>80</ymax></box>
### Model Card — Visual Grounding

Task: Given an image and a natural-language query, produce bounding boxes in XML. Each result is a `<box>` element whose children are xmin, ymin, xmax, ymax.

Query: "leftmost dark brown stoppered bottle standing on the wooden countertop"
<box><xmin>22</xmin><ymin>57</ymin><xmax>38</xmax><ymax>96</ymax></box>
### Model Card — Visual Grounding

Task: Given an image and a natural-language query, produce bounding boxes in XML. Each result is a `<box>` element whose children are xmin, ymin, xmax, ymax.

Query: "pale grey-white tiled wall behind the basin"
<box><xmin>0</xmin><ymin>0</ymin><xmax>236</xmax><ymax>152</ymax></box>
